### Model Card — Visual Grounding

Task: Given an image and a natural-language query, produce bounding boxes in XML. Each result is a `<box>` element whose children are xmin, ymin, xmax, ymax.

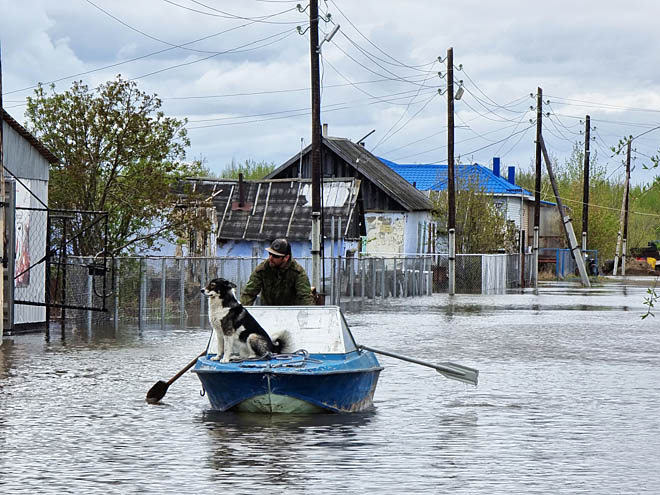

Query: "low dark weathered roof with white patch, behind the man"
<box><xmin>183</xmin><ymin>178</ymin><xmax>360</xmax><ymax>241</ymax></box>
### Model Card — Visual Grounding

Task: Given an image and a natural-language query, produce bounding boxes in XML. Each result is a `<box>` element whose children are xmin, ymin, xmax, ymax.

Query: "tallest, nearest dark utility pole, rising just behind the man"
<box><xmin>309</xmin><ymin>0</ymin><xmax>321</xmax><ymax>290</ymax></box>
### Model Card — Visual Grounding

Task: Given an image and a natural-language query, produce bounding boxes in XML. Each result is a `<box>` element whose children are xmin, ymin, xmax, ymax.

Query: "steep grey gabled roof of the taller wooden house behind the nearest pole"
<box><xmin>266</xmin><ymin>137</ymin><xmax>432</xmax><ymax>211</ymax></box>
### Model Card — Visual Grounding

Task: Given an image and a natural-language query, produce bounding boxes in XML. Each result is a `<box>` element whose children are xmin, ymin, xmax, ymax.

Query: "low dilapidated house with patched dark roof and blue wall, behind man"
<box><xmin>176</xmin><ymin>177</ymin><xmax>365</xmax><ymax>258</ymax></box>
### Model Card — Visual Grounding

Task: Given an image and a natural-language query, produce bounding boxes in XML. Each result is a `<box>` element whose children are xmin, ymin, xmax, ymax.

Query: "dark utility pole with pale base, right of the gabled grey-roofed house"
<box><xmin>447</xmin><ymin>47</ymin><xmax>456</xmax><ymax>295</ymax></box>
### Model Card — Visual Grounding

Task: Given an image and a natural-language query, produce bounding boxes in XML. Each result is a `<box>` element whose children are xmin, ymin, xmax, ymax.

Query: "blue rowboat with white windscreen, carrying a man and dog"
<box><xmin>193</xmin><ymin>306</ymin><xmax>382</xmax><ymax>414</ymax></box>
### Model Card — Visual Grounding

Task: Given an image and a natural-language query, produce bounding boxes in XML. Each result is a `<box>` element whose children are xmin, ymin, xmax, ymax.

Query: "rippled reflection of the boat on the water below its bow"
<box><xmin>199</xmin><ymin>411</ymin><xmax>374</xmax><ymax>489</ymax></box>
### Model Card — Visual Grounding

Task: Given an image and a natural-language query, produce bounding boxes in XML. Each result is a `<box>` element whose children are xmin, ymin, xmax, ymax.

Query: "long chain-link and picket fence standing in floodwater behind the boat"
<box><xmin>58</xmin><ymin>254</ymin><xmax>534</xmax><ymax>324</ymax></box>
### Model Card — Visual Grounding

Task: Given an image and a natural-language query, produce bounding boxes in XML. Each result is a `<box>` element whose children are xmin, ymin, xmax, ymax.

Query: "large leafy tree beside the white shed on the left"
<box><xmin>26</xmin><ymin>75</ymin><xmax>206</xmax><ymax>255</ymax></box>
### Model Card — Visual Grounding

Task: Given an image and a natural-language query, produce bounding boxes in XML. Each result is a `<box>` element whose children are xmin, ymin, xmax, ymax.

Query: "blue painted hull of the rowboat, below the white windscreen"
<box><xmin>193</xmin><ymin>351</ymin><xmax>382</xmax><ymax>413</ymax></box>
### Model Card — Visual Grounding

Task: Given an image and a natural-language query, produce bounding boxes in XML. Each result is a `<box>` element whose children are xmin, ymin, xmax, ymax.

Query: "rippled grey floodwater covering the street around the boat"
<box><xmin>0</xmin><ymin>280</ymin><xmax>660</xmax><ymax>494</ymax></box>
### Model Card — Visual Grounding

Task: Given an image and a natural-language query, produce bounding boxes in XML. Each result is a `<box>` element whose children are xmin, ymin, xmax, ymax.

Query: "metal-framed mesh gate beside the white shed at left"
<box><xmin>14</xmin><ymin>207</ymin><xmax>114</xmax><ymax>326</ymax></box>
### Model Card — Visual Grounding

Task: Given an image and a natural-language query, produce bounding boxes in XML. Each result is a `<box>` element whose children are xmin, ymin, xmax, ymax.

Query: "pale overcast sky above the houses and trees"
<box><xmin>0</xmin><ymin>0</ymin><xmax>660</xmax><ymax>183</ymax></box>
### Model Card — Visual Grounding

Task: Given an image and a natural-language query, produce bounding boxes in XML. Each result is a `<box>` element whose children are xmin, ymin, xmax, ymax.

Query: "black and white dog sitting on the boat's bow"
<box><xmin>202</xmin><ymin>278</ymin><xmax>286</xmax><ymax>363</ymax></box>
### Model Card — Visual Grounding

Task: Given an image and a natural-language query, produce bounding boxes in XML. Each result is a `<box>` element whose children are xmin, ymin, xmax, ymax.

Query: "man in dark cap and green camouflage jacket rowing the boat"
<box><xmin>241</xmin><ymin>239</ymin><xmax>314</xmax><ymax>306</ymax></box>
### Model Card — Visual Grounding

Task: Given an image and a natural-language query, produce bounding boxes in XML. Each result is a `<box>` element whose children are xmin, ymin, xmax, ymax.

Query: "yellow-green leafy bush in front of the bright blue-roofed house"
<box><xmin>431</xmin><ymin>174</ymin><xmax>516</xmax><ymax>254</ymax></box>
